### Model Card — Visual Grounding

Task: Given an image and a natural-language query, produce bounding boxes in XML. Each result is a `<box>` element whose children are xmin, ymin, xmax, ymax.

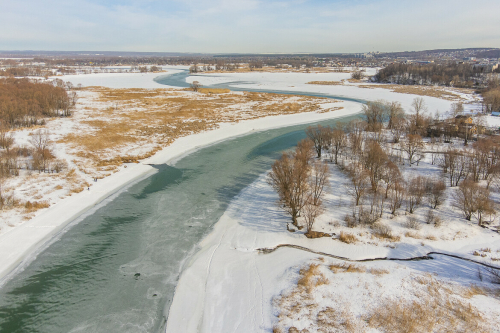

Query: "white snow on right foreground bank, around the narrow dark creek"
<box><xmin>166</xmin><ymin>169</ymin><xmax>500</xmax><ymax>332</ymax></box>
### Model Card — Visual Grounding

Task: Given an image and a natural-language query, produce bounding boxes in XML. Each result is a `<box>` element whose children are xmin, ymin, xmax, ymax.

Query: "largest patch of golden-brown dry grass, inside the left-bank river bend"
<box><xmin>59</xmin><ymin>87</ymin><xmax>340</xmax><ymax>169</ymax></box>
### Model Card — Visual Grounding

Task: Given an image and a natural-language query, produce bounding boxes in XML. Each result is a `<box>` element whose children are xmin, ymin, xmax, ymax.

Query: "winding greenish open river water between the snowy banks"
<box><xmin>0</xmin><ymin>72</ymin><xmax>362</xmax><ymax>333</ymax></box>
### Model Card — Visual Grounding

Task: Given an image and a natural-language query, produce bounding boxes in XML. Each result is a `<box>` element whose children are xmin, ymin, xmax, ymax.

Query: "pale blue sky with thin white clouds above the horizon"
<box><xmin>0</xmin><ymin>0</ymin><xmax>500</xmax><ymax>53</ymax></box>
